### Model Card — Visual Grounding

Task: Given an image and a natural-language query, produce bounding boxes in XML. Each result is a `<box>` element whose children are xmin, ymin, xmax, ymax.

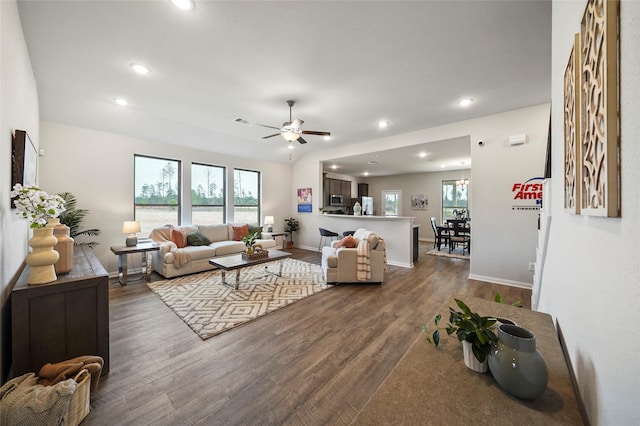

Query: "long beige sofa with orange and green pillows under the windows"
<box><xmin>149</xmin><ymin>224</ymin><xmax>276</xmax><ymax>278</ymax></box>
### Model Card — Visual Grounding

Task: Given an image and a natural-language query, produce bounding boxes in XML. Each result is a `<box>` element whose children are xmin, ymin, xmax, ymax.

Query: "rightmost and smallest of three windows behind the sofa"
<box><xmin>233</xmin><ymin>169</ymin><xmax>260</xmax><ymax>225</ymax></box>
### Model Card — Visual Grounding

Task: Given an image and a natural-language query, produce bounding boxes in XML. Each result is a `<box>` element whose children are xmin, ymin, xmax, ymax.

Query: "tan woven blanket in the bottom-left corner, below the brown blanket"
<box><xmin>0</xmin><ymin>373</ymin><xmax>77</xmax><ymax>426</ymax></box>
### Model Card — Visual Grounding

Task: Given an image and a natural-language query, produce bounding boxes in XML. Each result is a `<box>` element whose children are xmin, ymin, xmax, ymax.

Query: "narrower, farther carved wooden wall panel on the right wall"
<box><xmin>564</xmin><ymin>34</ymin><xmax>580</xmax><ymax>213</ymax></box>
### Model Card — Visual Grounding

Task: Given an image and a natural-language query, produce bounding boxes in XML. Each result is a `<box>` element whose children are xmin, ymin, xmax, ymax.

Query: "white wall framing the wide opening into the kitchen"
<box><xmin>291</xmin><ymin>104</ymin><xmax>549</xmax><ymax>287</ymax></box>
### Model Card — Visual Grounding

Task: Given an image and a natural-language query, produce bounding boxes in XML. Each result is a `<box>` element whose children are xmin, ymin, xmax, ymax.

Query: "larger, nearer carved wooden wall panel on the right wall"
<box><xmin>579</xmin><ymin>0</ymin><xmax>621</xmax><ymax>217</ymax></box>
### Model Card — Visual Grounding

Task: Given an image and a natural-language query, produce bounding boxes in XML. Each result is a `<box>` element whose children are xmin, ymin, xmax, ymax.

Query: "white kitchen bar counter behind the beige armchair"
<box><xmin>319</xmin><ymin>214</ymin><xmax>417</xmax><ymax>268</ymax></box>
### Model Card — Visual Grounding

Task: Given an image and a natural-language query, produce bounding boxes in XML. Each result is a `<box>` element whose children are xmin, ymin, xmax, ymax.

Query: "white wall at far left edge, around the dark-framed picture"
<box><xmin>0</xmin><ymin>1</ymin><xmax>40</xmax><ymax>292</ymax></box>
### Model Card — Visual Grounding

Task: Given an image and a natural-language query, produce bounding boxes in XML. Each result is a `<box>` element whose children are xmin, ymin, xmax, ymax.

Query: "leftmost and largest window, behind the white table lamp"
<box><xmin>134</xmin><ymin>155</ymin><xmax>180</xmax><ymax>236</ymax></box>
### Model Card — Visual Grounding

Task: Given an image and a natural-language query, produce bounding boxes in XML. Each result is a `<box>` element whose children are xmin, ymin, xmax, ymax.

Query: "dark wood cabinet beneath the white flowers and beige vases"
<box><xmin>11</xmin><ymin>246</ymin><xmax>109</xmax><ymax>377</ymax></box>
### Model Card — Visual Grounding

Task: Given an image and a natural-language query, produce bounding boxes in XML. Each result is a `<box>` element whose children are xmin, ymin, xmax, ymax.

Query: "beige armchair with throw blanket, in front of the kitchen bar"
<box><xmin>322</xmin><ymin>228</ymin><xmax>387</xmax><ymax>284</ymax></box>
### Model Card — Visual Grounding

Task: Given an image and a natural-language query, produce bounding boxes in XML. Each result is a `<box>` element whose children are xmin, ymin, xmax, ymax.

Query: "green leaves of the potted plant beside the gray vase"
<box><xmin>422</xmin><ymin>299</ymin><xmax>498</xmax><ymax>362</ymax></box>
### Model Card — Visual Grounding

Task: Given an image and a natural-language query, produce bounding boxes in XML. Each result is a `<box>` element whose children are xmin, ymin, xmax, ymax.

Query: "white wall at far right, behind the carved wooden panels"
<box><xmin>538</xmin><ymin>0</ymin><xmax>640</xmax><ymax>425</ymax></box>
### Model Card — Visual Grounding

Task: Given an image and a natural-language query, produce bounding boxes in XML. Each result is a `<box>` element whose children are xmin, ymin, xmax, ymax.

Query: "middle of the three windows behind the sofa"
<box><xmin>191</xmin><ymin>163</ymin><xmax>227</xmax><ymax>224</ymax></box>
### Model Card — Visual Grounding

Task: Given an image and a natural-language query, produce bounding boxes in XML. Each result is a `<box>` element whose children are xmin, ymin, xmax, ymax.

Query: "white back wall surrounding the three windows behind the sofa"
<box><xmin>40</xmin><ymin>122</ymin><xmax>295</xmax><ymax>273</ymax></box>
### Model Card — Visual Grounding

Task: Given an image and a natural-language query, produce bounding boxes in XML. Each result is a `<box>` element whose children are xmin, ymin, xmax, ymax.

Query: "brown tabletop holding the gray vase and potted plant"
<box><xmin>352</xmin><ymin>296</ymin><xmax>584</xmax><ymax>425</ymax></box>
